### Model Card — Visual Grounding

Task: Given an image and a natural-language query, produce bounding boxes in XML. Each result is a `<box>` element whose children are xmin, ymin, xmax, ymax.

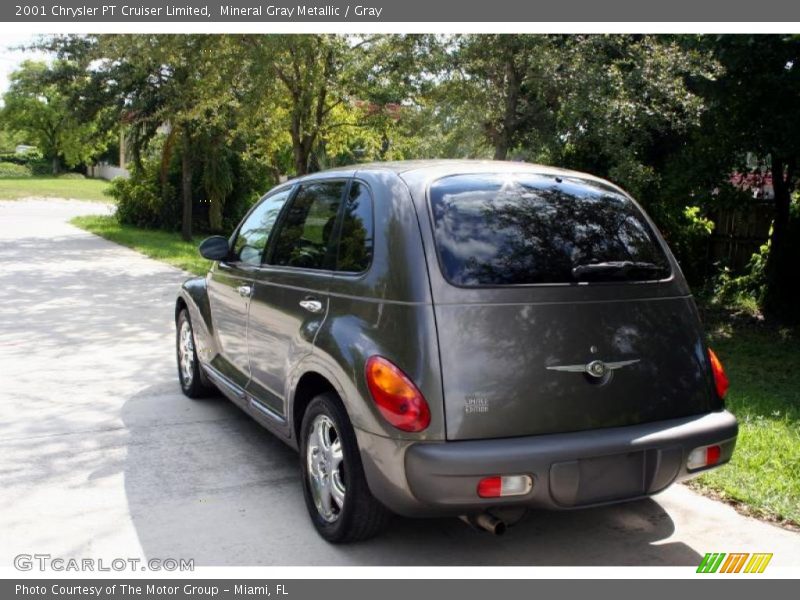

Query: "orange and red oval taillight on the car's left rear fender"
<box><xmin>367</xmin><ymin>356</ymin><xmax>431</xmax><ymax>431</ymax></box>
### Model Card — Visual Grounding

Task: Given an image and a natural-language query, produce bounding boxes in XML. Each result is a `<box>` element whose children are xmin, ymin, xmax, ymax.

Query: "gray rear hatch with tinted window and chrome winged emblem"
<box><xmin>429</xmin><ymin>174</ymin><xmax>720</xmax><ymax>439</ymax></box>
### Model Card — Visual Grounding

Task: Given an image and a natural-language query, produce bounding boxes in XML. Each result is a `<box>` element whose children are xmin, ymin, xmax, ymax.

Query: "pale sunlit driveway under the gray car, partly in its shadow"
<box><xmin>0</xmin><ymin>200</ymin><xmax>800</xmax><ymax>567</ymax></box>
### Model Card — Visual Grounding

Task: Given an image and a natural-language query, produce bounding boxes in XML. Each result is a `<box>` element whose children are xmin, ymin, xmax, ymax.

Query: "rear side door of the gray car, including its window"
<box><xmin>247</xmin><ymin>179</ymin><xmax>347</xmax><ymax>417</ymax></box>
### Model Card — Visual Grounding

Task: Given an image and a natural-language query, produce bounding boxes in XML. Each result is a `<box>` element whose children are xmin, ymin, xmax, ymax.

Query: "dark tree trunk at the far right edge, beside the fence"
<box><xmin>764</xmin><ymin>154</ymin><xmax>800</xmax><ymax>321</ymax></box>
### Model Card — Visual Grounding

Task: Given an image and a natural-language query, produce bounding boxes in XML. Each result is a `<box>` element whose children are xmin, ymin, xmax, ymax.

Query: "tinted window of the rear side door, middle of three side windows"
<box><xmin>271</xmin><ymin>181</ymin><xmax>346</xmax><ymax>269</ymax></box>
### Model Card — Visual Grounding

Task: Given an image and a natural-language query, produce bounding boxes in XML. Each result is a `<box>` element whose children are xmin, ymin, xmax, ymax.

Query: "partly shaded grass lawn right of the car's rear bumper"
<box><xmin>690</xmin><ymin>324</ymin><xmax>800</xmax><ymax>526</ymax></box>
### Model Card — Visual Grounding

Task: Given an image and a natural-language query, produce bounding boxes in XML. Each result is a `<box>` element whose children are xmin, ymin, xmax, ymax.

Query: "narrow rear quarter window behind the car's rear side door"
<box><xmin>336</xmin><ymin>181</ymin><xmax>373</xmax><ymax>273</ymax></box>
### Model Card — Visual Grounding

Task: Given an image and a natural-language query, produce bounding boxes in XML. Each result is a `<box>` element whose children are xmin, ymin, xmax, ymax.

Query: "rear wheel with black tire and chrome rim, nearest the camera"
<box><xmin>300</xmin><ymin>393</ymin><xmax>391</xmax><ymax>544</ymax></box>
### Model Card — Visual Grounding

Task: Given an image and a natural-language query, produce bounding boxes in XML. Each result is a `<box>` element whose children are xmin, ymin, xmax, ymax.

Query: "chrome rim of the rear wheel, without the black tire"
<box><xmin>306</xmin><ymin>415</ymin><xmax>346</xmax><ymax>523</ymax></box>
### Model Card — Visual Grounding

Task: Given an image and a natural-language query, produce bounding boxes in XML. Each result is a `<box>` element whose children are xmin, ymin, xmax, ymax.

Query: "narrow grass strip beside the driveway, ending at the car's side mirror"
<box><xmin>70</xmin><ymin>215</ymin><xmax>211</xmax><ymax>275</ymax></box>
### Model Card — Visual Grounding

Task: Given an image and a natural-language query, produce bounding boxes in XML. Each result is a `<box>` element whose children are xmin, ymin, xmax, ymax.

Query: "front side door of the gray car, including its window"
<box><xmin>208</xmin><ymin>187</ymin><xmax>293</xmax><ymax>389</ymax></box>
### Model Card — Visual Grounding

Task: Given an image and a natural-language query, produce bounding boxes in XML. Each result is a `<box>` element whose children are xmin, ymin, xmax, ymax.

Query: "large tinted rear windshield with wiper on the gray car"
<box><xmin>430</xmin><ymin>175</ymin><xmax>670</xmax><ymax>286</ymax></box>
